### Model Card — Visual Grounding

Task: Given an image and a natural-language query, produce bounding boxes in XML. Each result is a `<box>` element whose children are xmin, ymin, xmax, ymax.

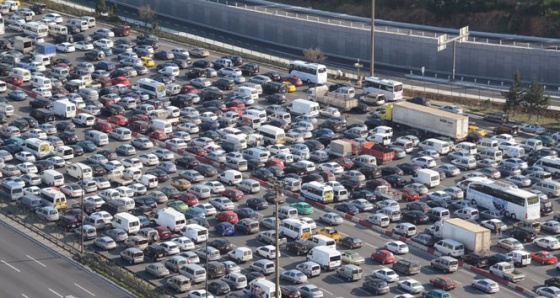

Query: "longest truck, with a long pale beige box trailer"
<box><xmin>380</xmin><ymin>102</ymin><xmax>469</xmax><ymax>142</ymax></box>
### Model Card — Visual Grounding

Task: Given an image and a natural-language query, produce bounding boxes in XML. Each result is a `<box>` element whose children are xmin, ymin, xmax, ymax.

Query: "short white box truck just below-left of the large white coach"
<box><xmin>429</xmin><ymin>218</ymin><xmax>491</xmax><ymax>254</ymax></box>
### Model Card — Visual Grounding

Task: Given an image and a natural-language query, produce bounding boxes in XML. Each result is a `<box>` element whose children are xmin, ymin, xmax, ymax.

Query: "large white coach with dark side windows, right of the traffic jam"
<box><xmin>466</xmin><ymin>181</ymin><xmax>541</xmax><ymax>221</ymax></box>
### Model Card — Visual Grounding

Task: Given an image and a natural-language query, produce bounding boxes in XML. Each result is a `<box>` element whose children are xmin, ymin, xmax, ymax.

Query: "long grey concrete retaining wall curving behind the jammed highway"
<box><xmin>119</xmin><ymin>0</ymin><xmax>560</xmax><ymax>84</ymax></box>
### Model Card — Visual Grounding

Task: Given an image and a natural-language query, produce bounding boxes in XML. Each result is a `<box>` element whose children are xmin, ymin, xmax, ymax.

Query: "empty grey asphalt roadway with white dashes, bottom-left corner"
<box><xmin>0</xmin><ymin>220</ymin><xmax>128</xmax><ymax>298</ymax></box>
